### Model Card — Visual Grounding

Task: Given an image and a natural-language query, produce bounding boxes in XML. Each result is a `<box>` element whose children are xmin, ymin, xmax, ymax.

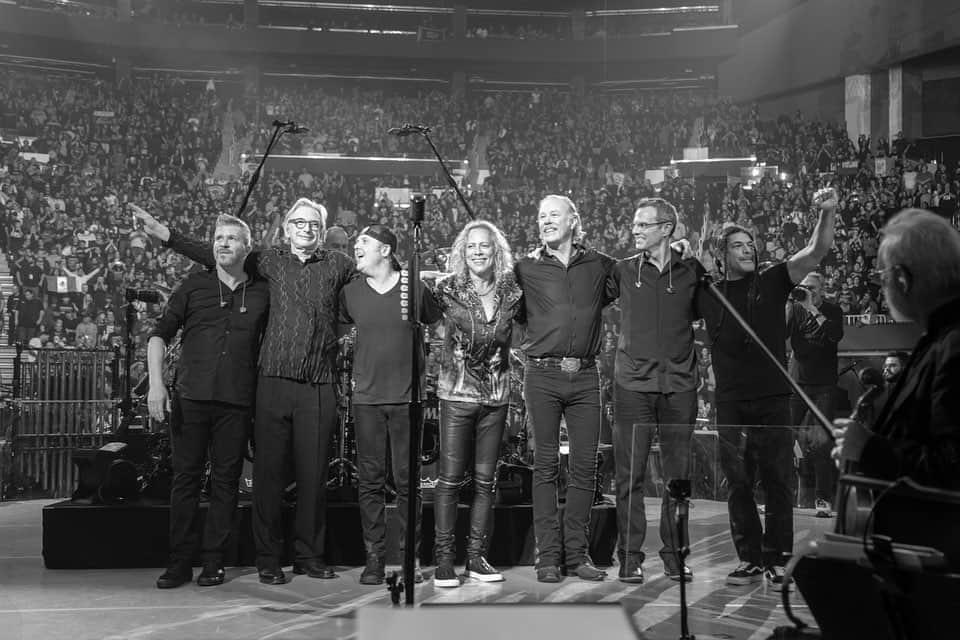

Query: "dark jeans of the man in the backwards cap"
<box><xmin>353</xmin><ymin>404</ymin><xmax>422</xmax><ymax>558</ymax></box>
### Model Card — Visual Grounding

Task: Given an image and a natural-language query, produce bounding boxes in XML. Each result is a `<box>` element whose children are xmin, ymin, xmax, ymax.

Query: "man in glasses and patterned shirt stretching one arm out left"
<box><xmin>133</xmin><ymin>198</ymin><xmax>354</xmax><ymax>584</ymax></box>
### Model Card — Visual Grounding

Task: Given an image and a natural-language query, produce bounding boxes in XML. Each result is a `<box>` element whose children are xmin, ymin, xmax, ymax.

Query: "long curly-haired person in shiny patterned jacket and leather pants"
<box><xmin>433</xmin><ymin>220</ymin><xmax>521</xmax><ymax>587</ymax></box>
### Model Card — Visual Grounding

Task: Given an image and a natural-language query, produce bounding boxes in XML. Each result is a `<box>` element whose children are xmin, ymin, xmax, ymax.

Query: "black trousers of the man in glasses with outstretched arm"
<box><xmin>253</xmin><ymin>376</ymin><xmax>337</xmax><ymax>569</ymax></box>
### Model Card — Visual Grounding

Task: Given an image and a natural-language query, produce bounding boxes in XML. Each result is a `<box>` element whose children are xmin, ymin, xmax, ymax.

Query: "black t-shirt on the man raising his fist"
<box><xmin>698</xmin><ymin>262</ymin><xmax>794</xmax><ymax>402</ymax></box>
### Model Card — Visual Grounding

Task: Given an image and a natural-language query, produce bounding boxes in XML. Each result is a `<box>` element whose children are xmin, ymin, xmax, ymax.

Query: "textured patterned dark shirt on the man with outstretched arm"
<box><xmin>167</xmin><ymin>230</ymin><xmax>354</xmax><ymax>383</ymax></box>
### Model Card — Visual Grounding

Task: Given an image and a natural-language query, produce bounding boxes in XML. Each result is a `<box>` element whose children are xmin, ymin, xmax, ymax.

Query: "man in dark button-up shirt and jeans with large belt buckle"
<box><xmin>516</xmin><ymin>195</ymin><xmax>616</xmax><ymax>582</ymax></box>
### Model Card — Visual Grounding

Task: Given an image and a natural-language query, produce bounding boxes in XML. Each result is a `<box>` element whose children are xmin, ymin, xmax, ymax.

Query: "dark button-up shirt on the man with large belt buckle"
<box><xmin>515</xmin><ymin>245</ymin><xmax>616</xmax><ymax>358</ymax></box>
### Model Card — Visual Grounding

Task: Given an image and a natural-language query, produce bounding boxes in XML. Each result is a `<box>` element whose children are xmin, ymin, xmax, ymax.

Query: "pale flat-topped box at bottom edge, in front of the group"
<box><xmin>357</xmin><ymin>603</ymin><xmax>643</xmax><ymax>640</ymax></box>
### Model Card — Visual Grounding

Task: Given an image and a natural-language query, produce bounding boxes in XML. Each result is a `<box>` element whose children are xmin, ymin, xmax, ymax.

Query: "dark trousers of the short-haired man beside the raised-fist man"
<box><xmin>613</xmin><ymin>385</ymin><xmax>697</xmax><ymax>570</ymax></box>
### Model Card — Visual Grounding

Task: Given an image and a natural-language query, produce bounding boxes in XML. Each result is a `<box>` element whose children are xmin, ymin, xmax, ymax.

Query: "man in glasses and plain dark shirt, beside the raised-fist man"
<box><xmin>613</xmin><ymin>198</ymin><xmax>705</xmax><ymax>583</ymax></box>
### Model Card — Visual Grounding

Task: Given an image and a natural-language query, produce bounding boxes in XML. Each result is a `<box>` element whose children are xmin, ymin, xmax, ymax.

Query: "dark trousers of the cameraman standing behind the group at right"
<box><xmin>790</xmin><ymin>384</ymin><xmax>839</xmax><ymax>502</ymax></box>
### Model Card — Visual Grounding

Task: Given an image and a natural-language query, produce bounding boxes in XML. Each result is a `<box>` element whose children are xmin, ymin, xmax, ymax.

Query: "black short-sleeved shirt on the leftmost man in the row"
<box><xmin>151</xmin><ymin>271</ymin><xmax>270</xmax><ymax>407</ymax></box>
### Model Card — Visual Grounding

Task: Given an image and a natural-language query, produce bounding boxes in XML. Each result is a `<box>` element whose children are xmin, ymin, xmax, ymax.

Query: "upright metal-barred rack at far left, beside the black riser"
<box><xmin>10</xmin><ymin>345</ymin><xmax>121</xmax><ymax>497</ymax></box>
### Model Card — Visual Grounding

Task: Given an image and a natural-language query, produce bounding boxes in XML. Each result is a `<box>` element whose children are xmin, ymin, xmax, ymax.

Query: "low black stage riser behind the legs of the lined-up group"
<box><xmin>43</xmin><ymin>500</ymin><xmax>617</xmax><ymax>569</ymax></box>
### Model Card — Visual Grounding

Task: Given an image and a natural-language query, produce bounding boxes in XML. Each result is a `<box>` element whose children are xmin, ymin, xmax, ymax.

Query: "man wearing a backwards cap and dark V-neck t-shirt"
<box><xmin>340</xmin><ymin>224</ymin><xmax>440</xmax><ymax>585</ymax></box>
